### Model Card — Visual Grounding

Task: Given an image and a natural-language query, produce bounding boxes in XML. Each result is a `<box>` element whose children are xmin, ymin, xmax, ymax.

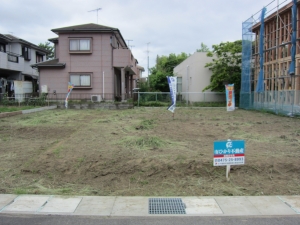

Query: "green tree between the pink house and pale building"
<box><xmin>149</xmin><ymin>53</ymin><xmax>189</xmax><ymax>92</ymax></box>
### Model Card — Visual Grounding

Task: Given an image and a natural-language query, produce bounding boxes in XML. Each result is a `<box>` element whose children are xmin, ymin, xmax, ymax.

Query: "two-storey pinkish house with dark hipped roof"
<box><xmin>32</xmin><ymin>23</ymin><xmax>144</xmax><ymax>101</ymax></box>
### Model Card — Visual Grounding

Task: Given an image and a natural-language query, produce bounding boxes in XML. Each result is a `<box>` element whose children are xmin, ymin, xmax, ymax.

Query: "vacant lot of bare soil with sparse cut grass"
<box><xmin>0</xmin><ymin>108</ymin><xmax>300</xmax><ymax>196</ymax></box>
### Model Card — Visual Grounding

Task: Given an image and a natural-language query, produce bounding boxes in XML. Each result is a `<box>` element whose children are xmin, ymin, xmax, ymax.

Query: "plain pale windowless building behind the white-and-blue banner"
<box><xmin>173</xmin><ymin>52</ymin><xmax>225</xmax><ymax>102</ymax></box>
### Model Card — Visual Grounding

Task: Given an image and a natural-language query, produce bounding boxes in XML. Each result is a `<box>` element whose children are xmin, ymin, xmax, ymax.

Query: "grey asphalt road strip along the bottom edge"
<box><xmin>0</xmin><ymin>214</ymin><xmax>300</xmax><ymax>225</ymax></box>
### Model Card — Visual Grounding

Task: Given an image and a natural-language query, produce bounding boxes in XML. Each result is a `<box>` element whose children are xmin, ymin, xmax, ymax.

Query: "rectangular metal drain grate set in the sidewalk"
<box><xmin>149</xmin><ymin>198</ymin><xmax>186</xmax><ymax>214</ymax></box>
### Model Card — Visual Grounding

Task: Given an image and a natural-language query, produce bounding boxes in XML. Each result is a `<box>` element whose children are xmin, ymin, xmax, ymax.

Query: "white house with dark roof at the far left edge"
<box><xmin>0</xmin><ymin>34</ymin><xmax>48</xmax><ymax>96</ymax></box>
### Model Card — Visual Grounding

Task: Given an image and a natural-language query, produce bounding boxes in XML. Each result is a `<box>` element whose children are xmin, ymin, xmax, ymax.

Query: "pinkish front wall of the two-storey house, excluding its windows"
<box><xmin>40</xmin><ymin>33</ymin><xmax>114</xmax><ymax>94</ymax></box>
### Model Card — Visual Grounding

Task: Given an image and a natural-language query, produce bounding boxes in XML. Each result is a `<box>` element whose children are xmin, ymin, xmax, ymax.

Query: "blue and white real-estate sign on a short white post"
<box><xmin>214</xmin><ymin>139</ymin><xmax>245</xmax><ymax>181</ymax></box>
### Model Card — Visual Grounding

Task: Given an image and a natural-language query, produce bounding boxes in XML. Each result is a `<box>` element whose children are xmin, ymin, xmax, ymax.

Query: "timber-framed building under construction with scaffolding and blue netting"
<box><xmin>240</xmin><ymin>0</ymin><xmax>300</xmax><ymax>115</ymax></box>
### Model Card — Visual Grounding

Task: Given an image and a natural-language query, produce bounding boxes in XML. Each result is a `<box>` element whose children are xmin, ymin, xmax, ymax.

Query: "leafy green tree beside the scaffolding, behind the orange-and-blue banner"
<box><xmin>203</xmin><ymin>40</ymin><xmax>242</xmax><ymax>93</ymax></box>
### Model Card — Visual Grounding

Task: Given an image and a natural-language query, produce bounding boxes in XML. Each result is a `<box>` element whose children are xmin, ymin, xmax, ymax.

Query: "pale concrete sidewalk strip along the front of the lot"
<box><xmin>0</xmin><ymin>194</ymin><xmax>300</xmax><ymax>216</ymax></box>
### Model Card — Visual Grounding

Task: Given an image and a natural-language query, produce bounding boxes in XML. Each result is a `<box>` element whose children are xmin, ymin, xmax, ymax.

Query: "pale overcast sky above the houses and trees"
<box><xmin>0</xmin><ymin>0</ymin><xmax>291</xmax><ymax>76</ymax></box>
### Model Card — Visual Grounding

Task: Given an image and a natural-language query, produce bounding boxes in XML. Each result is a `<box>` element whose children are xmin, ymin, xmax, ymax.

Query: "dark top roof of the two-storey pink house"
<box><xmin>51</xmin><ymin>23</ymin><xmax>118</xmax><ymax>33</ymax></box>
